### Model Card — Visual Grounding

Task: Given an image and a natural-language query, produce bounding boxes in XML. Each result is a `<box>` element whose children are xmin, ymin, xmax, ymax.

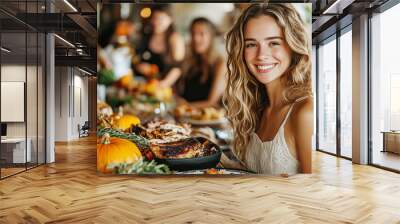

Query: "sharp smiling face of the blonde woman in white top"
<box><xmin>244</xmin><ymin>15</ymin><xmax>292</xmax><ymax>84</ymax></box>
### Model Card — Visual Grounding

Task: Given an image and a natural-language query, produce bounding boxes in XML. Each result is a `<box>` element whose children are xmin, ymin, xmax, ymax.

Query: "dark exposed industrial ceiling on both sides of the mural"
<box><xmin>0</xmin><ymin>0</ymin><xmax>396</xmax><ymax>73</ymax></box>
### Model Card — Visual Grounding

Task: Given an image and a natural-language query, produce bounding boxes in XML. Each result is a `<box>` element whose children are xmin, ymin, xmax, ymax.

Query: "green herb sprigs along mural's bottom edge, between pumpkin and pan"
<box><xmin>107</xmin><ymin>158</ymin><xmax>171</xmax><ymax>174</ymax></box>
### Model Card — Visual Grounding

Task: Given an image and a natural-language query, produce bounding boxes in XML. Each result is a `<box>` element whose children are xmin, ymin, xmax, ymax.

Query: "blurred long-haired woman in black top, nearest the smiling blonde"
<box><xmin>180</xmin><ymin>17</ymin><xmax>226</xmax><ymax>108</ymax></box>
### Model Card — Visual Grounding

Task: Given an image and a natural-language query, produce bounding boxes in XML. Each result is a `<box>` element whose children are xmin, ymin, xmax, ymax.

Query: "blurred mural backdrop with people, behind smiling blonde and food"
<box><xmin>97</xmin><ymin>3</ymin><xmax>312</xmax><ymax>108</ymax></box>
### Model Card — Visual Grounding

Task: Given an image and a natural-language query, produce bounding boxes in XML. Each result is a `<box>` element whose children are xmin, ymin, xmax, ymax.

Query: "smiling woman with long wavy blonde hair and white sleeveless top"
<box><xmin>224</xmin><ymin>4</ymin><xmax>313</xmax><ymax>175</ymax></box>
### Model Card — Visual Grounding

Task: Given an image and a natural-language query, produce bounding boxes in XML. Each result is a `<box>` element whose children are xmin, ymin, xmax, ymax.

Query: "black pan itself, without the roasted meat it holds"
<box><xmin>155</xmin><ymin>137</ymin><xmax>221</xmax><ymax>171</ymax></box>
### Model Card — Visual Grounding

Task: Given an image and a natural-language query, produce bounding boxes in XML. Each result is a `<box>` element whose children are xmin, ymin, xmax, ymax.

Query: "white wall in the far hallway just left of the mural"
<box><xmin>55</xmin><ymin>67</ymin><xmax>88</xmax><ymax>141</ymax></box>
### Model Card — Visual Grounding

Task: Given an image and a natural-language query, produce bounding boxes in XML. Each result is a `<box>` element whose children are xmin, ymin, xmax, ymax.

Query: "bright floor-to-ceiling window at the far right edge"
<box><xmin>370</xmin><ymin>1</ymin><xmax>400</xmax><ymax>170</ymax></box>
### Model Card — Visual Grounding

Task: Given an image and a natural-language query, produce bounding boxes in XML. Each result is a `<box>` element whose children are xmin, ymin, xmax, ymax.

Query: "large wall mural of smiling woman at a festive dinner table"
<box><xmin>97</xmin><ymin>3</ymin><xmax>314</xmax><ymax>176</ymax></box>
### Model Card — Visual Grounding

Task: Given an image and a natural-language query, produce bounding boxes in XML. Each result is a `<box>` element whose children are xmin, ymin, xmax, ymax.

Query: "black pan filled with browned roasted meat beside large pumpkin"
<box><xmin>150</xmin><ymin>137</ymin><xmax>221</xmax><ymax>171</ymax></box>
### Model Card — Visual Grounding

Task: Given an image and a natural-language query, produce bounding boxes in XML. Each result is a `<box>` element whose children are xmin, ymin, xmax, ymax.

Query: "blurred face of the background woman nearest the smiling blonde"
<box><xmin>192</xmin><ymin>23</ymin><xmax>212</xmax><ymax>54</ymax></box>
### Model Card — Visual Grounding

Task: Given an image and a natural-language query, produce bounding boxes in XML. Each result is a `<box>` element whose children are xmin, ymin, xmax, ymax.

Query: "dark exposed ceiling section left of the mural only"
<box><xmin>0</xmin><ymin>0</ymin><xmax>97</xmax><ymax>74</ymax></box>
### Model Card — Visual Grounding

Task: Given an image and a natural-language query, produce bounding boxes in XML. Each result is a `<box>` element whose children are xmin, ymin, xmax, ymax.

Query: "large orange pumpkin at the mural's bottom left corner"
<box><xmin>97</xmin><ymin>133</ymin><xmax>142</xmax><ymax>173</ymax></box>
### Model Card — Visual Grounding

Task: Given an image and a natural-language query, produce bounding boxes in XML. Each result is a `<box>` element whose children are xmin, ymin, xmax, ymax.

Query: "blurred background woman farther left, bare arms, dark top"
<box><xmin>135</xmin><ymin>5</ymin><xmax>185</xmax><ymax>87</ymax></box>
